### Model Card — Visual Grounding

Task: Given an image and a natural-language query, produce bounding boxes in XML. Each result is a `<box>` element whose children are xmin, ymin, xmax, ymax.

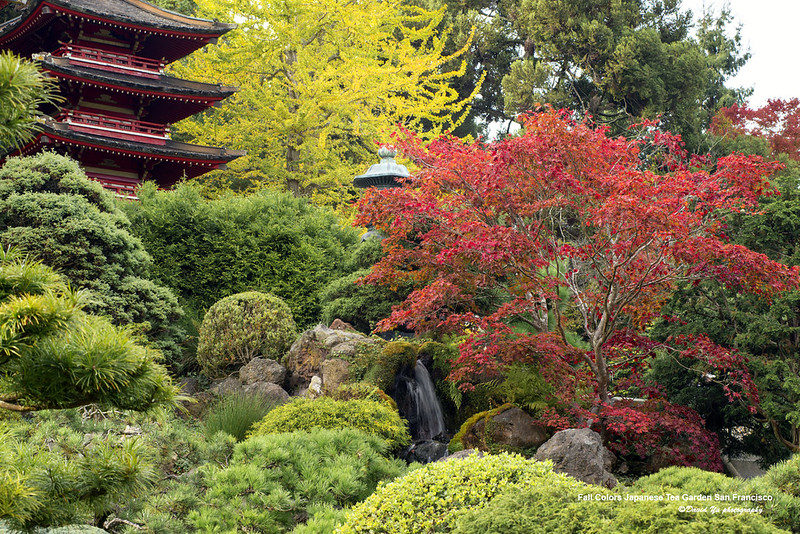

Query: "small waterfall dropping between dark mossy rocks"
<box><xmin>392</xmin><ymin>361</ymin><xmax>445</xmax><ymax>441</ymax></box>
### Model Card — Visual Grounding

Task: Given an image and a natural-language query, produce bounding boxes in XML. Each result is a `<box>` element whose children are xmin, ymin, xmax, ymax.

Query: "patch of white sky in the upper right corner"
<box><xmin>681</xmin><ymin>0</ymin><xmax>800</xmax><ymax>107</ymax></box>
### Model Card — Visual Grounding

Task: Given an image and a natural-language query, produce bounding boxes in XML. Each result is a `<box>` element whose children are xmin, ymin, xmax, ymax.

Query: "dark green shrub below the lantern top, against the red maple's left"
<box><xmin>320</xmin><ymin>238</ymin><xmax>408</xmax><ymax>334</ymax></box>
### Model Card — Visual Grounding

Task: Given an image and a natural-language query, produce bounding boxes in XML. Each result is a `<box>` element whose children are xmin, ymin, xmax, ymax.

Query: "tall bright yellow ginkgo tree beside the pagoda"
<box><xmin>173</xmin><ymin>0</ymin><xmax>474</xmax><ymax>202</ymax></box>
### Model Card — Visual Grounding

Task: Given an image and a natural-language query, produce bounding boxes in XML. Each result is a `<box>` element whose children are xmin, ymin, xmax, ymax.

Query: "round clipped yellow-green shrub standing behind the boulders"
<box><xmin>197</xmin><ymin>291</ymin><xmax>297</xmax><ymax>378</ymax></box>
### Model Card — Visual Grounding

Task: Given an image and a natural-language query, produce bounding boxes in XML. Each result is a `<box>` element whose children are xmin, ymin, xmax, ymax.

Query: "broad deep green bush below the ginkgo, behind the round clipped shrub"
<box><xmin>125</xmin><ymin>184</ymin><xmax>356</xmax><ymax>328</ymax></box>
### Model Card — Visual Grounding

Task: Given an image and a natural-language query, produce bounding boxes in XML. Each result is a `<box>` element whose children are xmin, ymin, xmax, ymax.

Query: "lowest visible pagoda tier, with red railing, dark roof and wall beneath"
<box><xmin>18</xmin><ymin>117</ymin><xmax>244</xmax><ymax>198</ymax></box>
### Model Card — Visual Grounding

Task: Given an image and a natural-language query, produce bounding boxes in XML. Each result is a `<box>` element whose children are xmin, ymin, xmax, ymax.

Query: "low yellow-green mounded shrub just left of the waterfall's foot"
<box><xmin>251</xmin><ymin>397</ymin><xmax>411</xmax><ymax>449</ymax></box>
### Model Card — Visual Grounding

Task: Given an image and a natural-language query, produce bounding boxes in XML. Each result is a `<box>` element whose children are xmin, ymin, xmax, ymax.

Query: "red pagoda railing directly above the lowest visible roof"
<box><xmin>55</xmin><ymin>109</ymin><xmax>169</xmax><ymax>145</ymax></box>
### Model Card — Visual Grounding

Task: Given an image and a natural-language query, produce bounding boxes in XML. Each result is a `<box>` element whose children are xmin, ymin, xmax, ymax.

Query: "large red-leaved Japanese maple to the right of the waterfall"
<box><xmin>357</xmin><ymin>109</ymin><xmax>798</xmax><ymax>464</ymax></box>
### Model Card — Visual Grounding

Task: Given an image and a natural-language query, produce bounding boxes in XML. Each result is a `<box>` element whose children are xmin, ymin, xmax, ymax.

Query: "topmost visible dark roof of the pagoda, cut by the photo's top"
<box><xmin>0</xmin><ymin>0</ymin><xmax>236</xmax><ymax>37</ymax></box>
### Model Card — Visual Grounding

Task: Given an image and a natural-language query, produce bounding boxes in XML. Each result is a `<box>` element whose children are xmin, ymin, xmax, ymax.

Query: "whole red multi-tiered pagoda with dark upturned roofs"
<box><xmin>0</xmin><ymin>0</ymin><xmax>244</xmax><ymax>197</ymax></box>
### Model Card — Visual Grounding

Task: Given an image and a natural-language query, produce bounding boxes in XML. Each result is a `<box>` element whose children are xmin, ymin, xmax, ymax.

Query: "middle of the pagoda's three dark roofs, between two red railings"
<box><xmin>40</xmin><ymin>54</ymin><xmax>236</xmax><ymax>102</ymax></box>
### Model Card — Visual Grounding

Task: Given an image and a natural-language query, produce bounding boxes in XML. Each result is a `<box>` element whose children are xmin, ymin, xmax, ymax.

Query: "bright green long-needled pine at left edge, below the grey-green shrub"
<box><xmin>0</xmin><ymin>250</ymin><xmax>176</xmax><ymax>411</ymax></box>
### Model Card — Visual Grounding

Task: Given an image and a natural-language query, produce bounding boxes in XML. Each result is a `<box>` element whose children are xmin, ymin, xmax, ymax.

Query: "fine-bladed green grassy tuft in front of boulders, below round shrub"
<box><xmin>205</xmin><ymin>392</ymin><xmax>277</xmax><ymax>441</ymax></box>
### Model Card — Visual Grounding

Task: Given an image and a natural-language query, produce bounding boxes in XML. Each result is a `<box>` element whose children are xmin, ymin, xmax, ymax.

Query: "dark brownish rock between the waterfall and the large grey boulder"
<box><xmin>461</xmin><ymin>407</ymin><xmax>547</xmax><ymax>450</ymax></box>
